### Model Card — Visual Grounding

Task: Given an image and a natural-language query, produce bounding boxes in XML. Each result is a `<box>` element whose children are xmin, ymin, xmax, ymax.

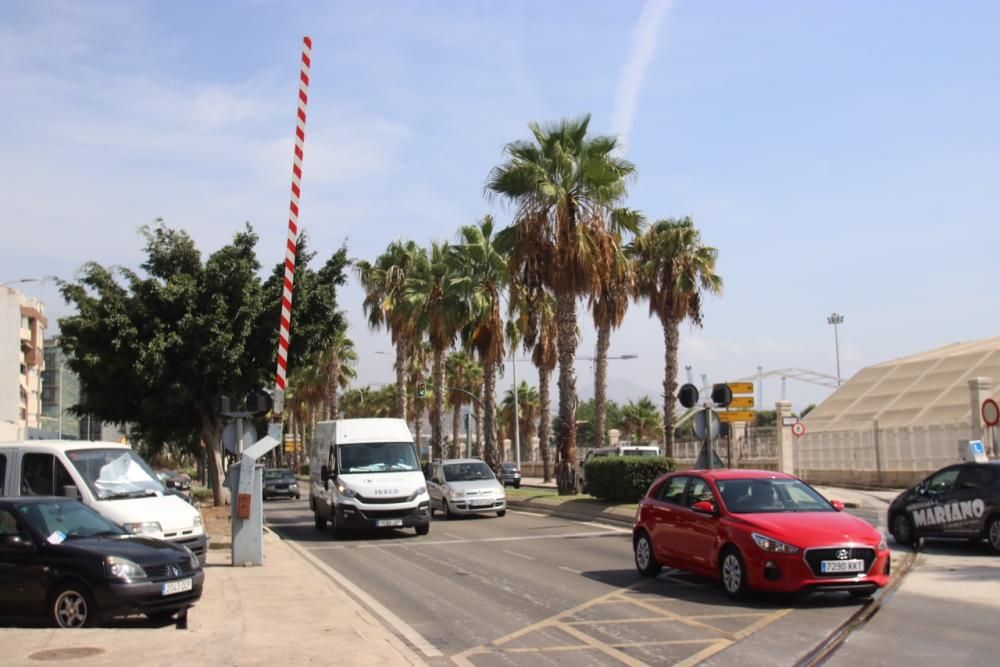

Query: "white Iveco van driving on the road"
<box><xmin>309</xmin><ymin>418</ymin><xmax>431</xmax><ymax>537</ymax></box>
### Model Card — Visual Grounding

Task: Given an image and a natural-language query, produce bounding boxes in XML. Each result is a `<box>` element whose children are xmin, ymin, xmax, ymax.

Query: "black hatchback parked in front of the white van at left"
<box><xmin>0</xmin><ymin>496</ymin><xmax>205</xmax><ymax>628</ymax></box>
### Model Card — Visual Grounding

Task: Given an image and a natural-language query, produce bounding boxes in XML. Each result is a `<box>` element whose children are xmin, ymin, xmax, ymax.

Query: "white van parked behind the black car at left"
<box><xmin>0</xmin><ymin>440</ymin><xmax>208</xmax><ymax>564</ymax></box>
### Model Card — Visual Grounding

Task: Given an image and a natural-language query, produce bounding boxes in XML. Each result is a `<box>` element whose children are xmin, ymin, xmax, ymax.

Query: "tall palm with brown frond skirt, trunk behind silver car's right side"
<box><xmin>453</xmin><ymin>215</ymin><xmax>507</xmax><ymax>473</ymax></box>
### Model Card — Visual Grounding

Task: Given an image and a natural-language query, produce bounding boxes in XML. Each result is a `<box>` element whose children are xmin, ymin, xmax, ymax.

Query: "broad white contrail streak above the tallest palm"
<box><xmin>611</xmin><ymin>0</ymin><xmax>673</xmax><ymax>153</ymax></box>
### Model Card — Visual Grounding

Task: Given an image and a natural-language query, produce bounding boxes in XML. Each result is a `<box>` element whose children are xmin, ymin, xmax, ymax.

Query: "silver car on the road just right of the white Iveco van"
<box><xmin>427</xmin><ymin>459</ymin><xmax>507</xmax><ymax>519</ymax></box>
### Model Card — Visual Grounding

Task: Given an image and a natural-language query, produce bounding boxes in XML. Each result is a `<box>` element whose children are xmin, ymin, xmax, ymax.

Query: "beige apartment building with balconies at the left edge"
<box><xmin>0</xmin><ymin>286</ymin><xmax>48</xmax><ymax>442</ymax></box>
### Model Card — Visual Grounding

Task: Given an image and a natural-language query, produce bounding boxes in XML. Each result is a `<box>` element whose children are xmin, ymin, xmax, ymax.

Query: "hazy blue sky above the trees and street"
<box><xmin>0</xmin><ymin>0</ymin><xmax>1000</xmax><ymax>407</ymax></box>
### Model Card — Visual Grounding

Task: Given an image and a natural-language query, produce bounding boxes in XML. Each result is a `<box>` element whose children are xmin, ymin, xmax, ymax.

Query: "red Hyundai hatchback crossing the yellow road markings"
<box><xmin>632</xmin><ymin>469</ymin><xmax>889</xmax><ymax>597</ymax></box>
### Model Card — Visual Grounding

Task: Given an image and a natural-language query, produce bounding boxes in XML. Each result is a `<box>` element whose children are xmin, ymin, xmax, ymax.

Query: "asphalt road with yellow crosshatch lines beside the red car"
<box><xmin>265</xmin><ymin>500</ymin><xmax>876</xmax><ymax>667</ymax></box>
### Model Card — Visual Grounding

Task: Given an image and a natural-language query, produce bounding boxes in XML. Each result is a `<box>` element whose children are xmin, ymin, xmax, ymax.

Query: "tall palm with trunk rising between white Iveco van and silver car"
<box><xmin>405</xmin><ymin>242</ymin><xmax>466</xmax><ymax>458</ymax></box>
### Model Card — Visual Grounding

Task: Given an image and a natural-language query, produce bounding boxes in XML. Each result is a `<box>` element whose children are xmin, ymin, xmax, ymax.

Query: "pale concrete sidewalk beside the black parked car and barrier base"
<box><xmin>0</xmin><ymin>531</ymin><xmax>424</xmax><ymax>667</ymax></box>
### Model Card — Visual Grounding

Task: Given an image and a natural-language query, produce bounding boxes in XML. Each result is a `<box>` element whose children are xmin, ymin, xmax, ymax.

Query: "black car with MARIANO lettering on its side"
<box><xmin>888</xmin><ymin>461</ymin><xmax>1000</xmax><ymax>552</ymax></box>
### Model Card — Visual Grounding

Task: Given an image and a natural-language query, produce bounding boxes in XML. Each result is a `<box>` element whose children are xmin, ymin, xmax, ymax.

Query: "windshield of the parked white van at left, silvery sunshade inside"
<box><xmin>66</xmin><ymin>448</ymin><xmax>166</xmax><ymax>500</ymax></box>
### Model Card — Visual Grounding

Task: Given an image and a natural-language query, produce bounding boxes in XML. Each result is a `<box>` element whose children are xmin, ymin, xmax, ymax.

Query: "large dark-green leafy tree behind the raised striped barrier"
<box><xmin>59</xmin><ymin>221</ymin><xmax>346</xmax><ymax>504</ymax></box>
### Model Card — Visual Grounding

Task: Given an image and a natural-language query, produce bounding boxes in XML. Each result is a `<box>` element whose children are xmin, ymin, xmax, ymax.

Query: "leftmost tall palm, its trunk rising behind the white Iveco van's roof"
<box><xmin>354</xmin><ymin>241</ymin><xmax>425</xmax><ymax>419</ymax></box>
